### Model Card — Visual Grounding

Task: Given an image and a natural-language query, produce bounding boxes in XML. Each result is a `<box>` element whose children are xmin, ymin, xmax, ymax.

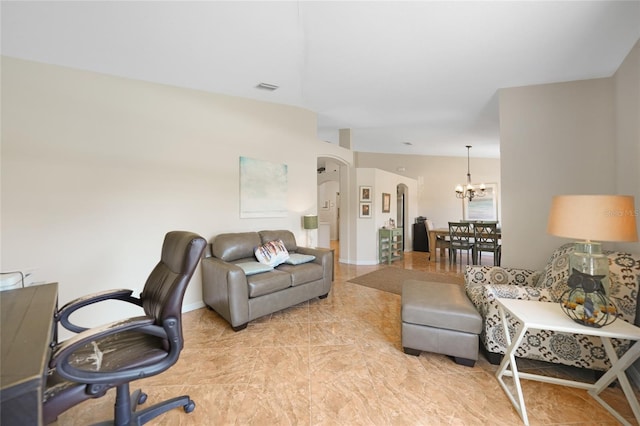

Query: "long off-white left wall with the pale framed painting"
<box><xmin>0</xmin><ymin>57</ymin><xmax>353</xmax><ymax>330</ymax></box>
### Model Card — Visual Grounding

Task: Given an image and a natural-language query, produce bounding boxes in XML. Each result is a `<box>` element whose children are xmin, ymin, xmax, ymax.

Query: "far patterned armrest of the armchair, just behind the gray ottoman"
<box><xmin>464</xmin><ymin>265</ymin><xmax>542</xmax><ymax>287</ymax></box>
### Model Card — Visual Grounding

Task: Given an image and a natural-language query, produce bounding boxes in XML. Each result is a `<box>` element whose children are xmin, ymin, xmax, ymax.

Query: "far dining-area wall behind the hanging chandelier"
<box><xmin>355</xmin><ymin>151</ymin><xmax>501</xmax><ymax>228</ymax></box>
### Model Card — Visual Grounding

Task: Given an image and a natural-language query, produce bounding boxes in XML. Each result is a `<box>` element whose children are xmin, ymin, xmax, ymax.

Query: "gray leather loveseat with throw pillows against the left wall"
<box><xmin>202</xmin><ymin>230</ymin><xmax>333</xmax><ymax>331</ymax></box>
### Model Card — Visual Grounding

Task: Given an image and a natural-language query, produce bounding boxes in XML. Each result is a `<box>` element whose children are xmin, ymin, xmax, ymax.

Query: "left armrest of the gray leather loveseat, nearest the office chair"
<box><xmin>202</xmin><ymin>257</ymin><xmax>249</xmax><ymax>327</ymax></box>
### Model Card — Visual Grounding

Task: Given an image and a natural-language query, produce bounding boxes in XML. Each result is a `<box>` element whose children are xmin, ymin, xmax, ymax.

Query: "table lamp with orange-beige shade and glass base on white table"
<box><xmin>547</xmin><ymin>195</ymin><xmax>638</xmax><ymax>327</ymax></box>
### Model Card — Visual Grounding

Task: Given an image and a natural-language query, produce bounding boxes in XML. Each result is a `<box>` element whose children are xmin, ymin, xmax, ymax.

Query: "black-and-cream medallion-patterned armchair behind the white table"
<box><xmin>465</xmin><ymin>244</ymin><xmax>640</xmax><ymax>370</ymax></box>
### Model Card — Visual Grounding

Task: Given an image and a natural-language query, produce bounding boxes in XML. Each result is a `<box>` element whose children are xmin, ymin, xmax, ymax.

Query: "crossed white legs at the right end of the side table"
<box><xmin>589</xmin><ymin>336</ymin><xmax>640</xmax><ymax>425</ymax></box>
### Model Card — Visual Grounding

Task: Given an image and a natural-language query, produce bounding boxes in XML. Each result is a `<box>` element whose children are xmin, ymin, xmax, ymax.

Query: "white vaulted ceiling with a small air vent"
<box><xmin>0</xmin><ymin>1</ymin><xmax>640</xmax><ymax>158</ymax></box>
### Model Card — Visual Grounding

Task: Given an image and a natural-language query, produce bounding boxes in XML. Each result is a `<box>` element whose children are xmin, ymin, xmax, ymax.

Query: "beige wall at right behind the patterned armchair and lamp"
<box><xmin>500</xmin><ymin>41</ymin><xmax>640</xmax><ymax>268</ymax></box>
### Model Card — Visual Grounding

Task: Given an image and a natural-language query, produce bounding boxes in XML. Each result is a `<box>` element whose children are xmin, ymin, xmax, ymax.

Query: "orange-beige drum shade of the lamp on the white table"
<box><xmin>547</xmin><ymin>195</ymin><xmax>638</xmax><ymax>241</ymax></box>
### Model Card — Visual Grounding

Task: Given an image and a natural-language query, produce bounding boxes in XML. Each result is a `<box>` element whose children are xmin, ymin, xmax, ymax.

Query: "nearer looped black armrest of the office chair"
<box><xmin>49</xmin><ymin>316</ymin><xmax>182</xmax><ymax>384</ymax></box>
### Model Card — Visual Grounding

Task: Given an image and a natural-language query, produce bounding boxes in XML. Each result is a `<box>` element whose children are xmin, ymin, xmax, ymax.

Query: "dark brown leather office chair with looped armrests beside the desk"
<box><xmin>43</xmin><ymin>231</ymin><xmax>206</xmax><ymax>425</ymax></box>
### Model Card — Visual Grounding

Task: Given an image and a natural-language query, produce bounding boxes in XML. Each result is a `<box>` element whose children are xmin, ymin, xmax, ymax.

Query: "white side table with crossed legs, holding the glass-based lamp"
<box><xmin>496</xmin><ymin>299</ymin><xmax>640</xmax><ymax>425</ymax></box>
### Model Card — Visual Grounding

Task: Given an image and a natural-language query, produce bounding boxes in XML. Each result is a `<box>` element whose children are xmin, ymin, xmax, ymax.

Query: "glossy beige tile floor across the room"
<box><xmin>57</xmin><ymin>246</ymin><xmax>640</xmax><ymax>426</ymax></box>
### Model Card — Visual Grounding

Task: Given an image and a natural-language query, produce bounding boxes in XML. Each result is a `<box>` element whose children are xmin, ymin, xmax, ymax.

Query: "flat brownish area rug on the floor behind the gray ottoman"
<box><xmin>348</xmin><ymin>266</ymin><xmax>464</xmax><ymax>294</ymax></box>
